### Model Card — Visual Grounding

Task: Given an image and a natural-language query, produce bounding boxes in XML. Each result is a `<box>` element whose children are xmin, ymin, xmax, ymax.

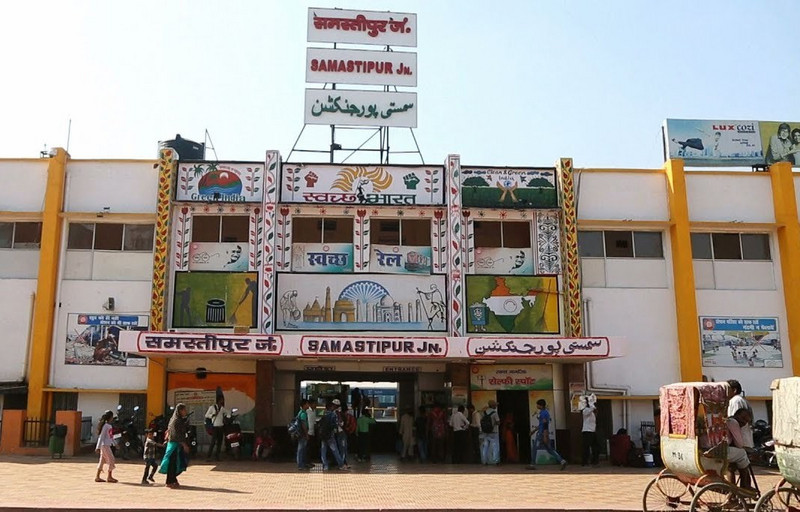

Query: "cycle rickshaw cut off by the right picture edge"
<box><xmin>756</xmin><ymin>377</ymin><xmax>800</xmax><ymax>512</ymax></box>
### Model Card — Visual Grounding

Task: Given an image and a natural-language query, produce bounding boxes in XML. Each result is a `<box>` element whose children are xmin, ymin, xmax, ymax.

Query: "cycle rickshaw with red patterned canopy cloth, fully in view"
<box><xmin>642</xmin><ymin>382</ymin><xmax>758</xmax><ymax>512</ymax></box>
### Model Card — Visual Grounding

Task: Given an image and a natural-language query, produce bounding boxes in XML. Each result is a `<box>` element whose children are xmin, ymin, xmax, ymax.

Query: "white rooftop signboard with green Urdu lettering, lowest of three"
<box><xmin>305</xmin><ymin>89</ymin><xmax>417</xmax><ymax>128</ymax></box>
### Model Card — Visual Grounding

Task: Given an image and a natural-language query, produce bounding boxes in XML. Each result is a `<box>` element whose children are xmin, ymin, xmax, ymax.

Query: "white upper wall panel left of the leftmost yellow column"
<box><xmin>0</xmin><ymin>158</ymin><xmax>49</xmax><ymax>212</ymax></box>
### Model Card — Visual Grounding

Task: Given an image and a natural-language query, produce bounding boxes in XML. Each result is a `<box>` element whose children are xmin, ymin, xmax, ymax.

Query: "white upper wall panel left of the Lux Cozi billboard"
<box><xmin>575</xmin><ymin>170</ymin><xmax>669</xmax><ymax>221</ymax></box>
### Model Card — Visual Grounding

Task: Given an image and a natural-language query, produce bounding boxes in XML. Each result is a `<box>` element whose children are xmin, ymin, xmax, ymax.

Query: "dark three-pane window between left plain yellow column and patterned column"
<box><xmin>67</xmin><ymin>222</ymin><xmax>155</xmax><ymax>252</ymax></box>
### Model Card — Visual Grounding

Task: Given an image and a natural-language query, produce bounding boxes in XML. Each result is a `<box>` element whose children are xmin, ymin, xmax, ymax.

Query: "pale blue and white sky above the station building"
<box><xmin>0</xmin><ymin>0</ymin><xmax>800</xmax><ymax>168</ymax></box>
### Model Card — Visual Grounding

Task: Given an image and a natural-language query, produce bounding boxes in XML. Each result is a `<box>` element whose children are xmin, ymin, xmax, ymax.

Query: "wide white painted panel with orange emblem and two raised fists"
<box><xmin>281</xmin><ymin>164</ymin><xmax>444</xmax><ymax>207</ymax></box>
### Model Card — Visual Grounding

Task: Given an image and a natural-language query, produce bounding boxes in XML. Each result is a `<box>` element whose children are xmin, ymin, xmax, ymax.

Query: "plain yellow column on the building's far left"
<box><xmin>28</xmin><ymin>148</ymin><xmax>69</xmax><ymax>418</ymax></box>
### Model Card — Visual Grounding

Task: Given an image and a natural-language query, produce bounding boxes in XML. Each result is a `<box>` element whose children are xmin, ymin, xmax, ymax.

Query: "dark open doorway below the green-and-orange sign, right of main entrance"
<box><xmin>497</xmin><ymin>390</ymin><xmax>531</xmax><ymax>463</ymax></box>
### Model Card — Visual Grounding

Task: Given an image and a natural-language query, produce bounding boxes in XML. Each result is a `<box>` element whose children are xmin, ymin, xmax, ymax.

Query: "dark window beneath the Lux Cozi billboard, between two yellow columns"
<box><xmin>692</xmin><ymin>233</ymin><xmax>772</xmax><ymax>261</ymax></box>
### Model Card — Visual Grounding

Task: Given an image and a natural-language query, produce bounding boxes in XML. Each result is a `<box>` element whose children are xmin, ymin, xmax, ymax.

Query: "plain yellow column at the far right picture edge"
<box><xmin>769</xmin><ymin>162</ymin><xmax>800</xmax><ymax>375</ymax></box>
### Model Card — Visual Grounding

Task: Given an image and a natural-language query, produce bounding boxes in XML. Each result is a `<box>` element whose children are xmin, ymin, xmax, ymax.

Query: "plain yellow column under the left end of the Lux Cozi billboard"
<box><xmin>664</xmin><ymin>160</ymin><xmax>703</xmax><ymax>382</ymax></box>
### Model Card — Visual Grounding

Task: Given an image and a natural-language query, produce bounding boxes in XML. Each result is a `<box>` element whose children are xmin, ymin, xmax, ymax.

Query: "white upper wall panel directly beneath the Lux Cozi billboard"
<box><xmin>686</xmin><ymin>171</ymin><xmax>775</xmax><ymax>222</ymax></box>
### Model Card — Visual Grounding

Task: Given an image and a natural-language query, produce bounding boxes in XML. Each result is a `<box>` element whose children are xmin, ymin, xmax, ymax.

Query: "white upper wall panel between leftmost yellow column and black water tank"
<box><xmin>64</xmin><ymin>160</ymin><xmax>158</xmax><ymax>213</ymax></box>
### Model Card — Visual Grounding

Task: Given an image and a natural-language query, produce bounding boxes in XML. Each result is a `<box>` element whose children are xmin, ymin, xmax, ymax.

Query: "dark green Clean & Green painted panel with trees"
<box><xmin>461</xmin><ymin>167</ymin><xmax>558</xmax><ymax>208</ymax></box>
